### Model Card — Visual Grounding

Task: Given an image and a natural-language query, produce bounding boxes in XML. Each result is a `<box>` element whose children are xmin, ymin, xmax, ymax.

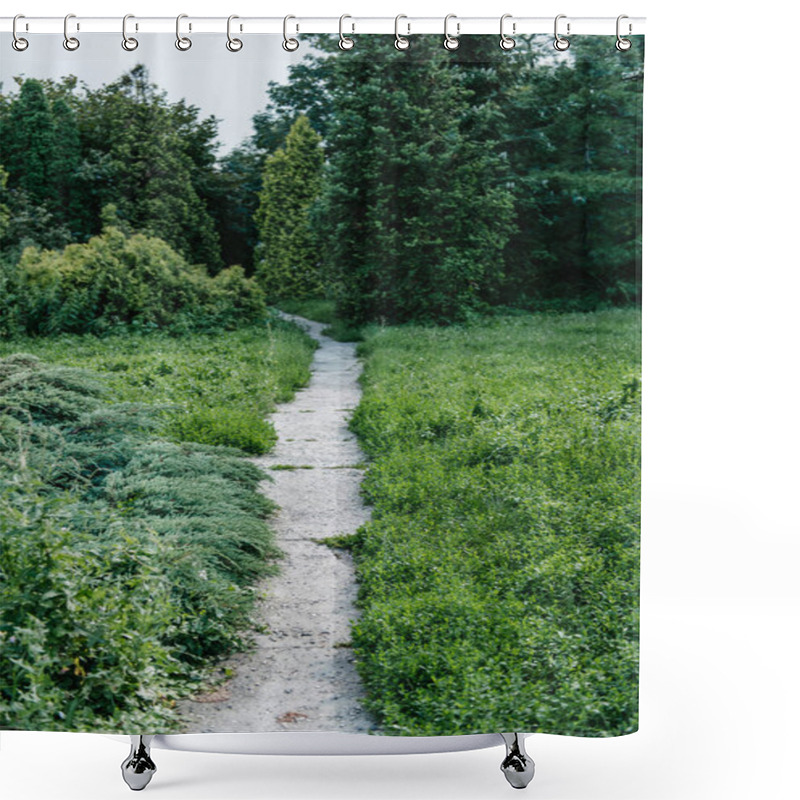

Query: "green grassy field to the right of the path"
<box><xmin>347</xmin><ymin>310</ymin><xmax>640</xmax><ymax>736</ymax></box>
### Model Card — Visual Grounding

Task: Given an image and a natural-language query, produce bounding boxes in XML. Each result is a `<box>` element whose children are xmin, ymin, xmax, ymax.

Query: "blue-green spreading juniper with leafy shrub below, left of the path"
<box><xmin>0</xmin><ymin>350</ymin><xmax>296</xmax><ymax>732</ymax></box>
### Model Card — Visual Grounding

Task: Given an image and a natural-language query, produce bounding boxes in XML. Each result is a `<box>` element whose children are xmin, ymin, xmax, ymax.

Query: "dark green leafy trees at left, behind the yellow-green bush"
<box><xmin>0</xmin><ymin>65</ymin><xmax>222</xmax><ymax>273</ymax></box>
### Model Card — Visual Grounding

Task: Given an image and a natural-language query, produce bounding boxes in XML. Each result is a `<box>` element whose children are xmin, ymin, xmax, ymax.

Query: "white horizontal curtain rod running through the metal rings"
<box><xmin>0</xmin><ymin>14</ymin><xmax>646</xmax><ymax>36</ymax></box>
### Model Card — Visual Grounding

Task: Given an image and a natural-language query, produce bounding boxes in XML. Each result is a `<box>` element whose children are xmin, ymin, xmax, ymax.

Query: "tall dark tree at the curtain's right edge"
<box><xmin>504</xmin><ymin>37</ymin><xmax>643</xmax><ymax>305</ymax></box>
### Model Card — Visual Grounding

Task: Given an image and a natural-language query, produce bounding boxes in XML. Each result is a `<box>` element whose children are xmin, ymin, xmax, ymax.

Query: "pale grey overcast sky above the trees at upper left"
<box><xmin>0</xmin><ymin>33</ymin><xmax>300</xmax><ymax>155</ymax></box>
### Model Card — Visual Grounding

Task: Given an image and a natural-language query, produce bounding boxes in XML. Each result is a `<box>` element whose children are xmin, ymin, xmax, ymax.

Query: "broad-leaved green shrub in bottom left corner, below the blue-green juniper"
<box><xmin>0</xmin><ymin>482</ymin><xmax>178</xmax><ymax>732</ymax></box>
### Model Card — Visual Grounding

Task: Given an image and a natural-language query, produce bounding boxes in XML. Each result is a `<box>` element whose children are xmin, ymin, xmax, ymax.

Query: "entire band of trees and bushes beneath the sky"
<box><xmin>0</xmin><ymin>36</ymin><xmax>643</xmax><ymax>335</ymax></box>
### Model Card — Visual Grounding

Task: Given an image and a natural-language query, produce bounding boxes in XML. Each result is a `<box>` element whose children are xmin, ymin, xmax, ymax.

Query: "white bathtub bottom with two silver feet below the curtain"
<box><xmin>119</xmin><ymin>732</ymin><xmax>534</xmax><ymax>792</ymax></box>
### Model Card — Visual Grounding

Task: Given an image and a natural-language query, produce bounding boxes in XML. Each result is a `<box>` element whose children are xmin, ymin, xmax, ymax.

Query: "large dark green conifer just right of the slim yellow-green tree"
<box><xmin>316</xmin><ymin>37</ymin><xmax>513</xmax><ymax>323</ymax></box>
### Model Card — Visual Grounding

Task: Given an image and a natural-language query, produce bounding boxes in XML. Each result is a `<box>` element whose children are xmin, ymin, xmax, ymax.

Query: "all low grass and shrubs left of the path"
<box><xmin>0</xmin><ymin>322</ymin><xmax>313</xmax><ymax>732</ymax></box>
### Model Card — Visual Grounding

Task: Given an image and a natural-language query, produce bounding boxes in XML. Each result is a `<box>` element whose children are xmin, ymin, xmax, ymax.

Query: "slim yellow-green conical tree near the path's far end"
<box><xmin>255</xmin><ymin>116</ymin><xmax>323</xmax><ymax>298</ymax></box>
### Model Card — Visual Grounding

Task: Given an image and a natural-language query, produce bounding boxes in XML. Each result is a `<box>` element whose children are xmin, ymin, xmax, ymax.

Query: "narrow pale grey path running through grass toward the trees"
<box><xmin>180</xmin><ymin>315</ymin><xmax>374</xmax><ymax>733</ymax></box>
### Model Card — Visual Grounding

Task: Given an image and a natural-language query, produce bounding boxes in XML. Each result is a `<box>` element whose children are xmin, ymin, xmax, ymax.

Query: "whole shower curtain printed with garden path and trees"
<box><xmin>0</xmin><ymin>25</ymin><xmax>644</xmax><ymax>736</ymax></box>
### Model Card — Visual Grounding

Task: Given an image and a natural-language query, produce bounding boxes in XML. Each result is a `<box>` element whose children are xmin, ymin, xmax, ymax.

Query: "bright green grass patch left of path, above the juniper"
<box><xmin>0</xmin><ymin>319</ymin><xmax>315</xmax><ymax>455</ymax></box>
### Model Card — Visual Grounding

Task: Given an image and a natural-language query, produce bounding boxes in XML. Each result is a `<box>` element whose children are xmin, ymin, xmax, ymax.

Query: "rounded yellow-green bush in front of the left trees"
<box><xmin>0</xmin><ymin>214</ymin><xmax>265</xmax><ymax>335</ymax></box>
